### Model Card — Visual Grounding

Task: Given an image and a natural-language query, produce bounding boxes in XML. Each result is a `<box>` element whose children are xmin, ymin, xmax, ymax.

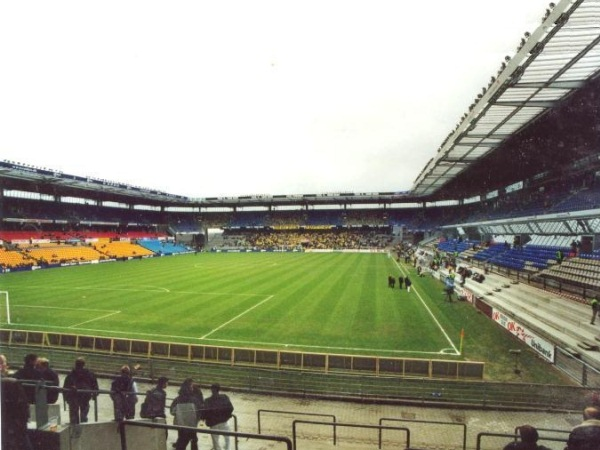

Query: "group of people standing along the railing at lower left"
<box><xmin>0</xmin><ymin>353</ymin><xmax>234</xmax><ymax>450</ymax></box>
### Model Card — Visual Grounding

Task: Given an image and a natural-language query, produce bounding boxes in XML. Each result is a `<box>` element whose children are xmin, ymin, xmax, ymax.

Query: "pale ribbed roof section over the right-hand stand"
<box><xmin>411</xmin><ymin>0</ymin><xmax>600</xmax><ymax>197</ymax></box>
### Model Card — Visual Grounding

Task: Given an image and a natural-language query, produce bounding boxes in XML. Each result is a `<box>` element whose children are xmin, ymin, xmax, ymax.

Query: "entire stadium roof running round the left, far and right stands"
<box><xmin>0</xmin><ymin>0</ymin><xmax>600</xmax><ymax>206</ymax></box>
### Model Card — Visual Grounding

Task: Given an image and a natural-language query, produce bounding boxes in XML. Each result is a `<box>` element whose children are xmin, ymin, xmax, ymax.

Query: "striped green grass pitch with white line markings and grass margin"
<box><xmin>0</xmin><ymin>253</ymin><xmax>576</xmax><ymax>382</ymax></box>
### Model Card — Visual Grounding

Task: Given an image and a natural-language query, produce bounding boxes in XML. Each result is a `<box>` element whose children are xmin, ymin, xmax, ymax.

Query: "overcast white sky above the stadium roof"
<box><xmin>0</xmin><ymin>0</ymin><xmax>549</xmax><ymax>197</ymax></box>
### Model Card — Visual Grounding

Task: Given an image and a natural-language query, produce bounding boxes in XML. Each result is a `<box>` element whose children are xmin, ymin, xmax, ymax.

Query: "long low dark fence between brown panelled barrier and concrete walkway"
<box><xmin>2</xmin><ymin>345</ymin><xmax>598</xmax><ymax>412</ymax></box>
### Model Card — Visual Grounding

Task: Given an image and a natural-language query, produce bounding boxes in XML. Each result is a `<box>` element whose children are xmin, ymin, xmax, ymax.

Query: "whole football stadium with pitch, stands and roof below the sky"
<box><xmin>0</xmin><ymin>0</ymin><xmax>600</xmax><ymax>450</ymax></box>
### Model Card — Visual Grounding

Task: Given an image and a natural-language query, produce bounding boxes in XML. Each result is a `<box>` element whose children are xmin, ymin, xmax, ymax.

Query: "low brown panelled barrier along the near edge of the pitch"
<box><xmin>0</xmin><ymin>329</ymin><xmax>485</xmax><ymax>380</ymax></box>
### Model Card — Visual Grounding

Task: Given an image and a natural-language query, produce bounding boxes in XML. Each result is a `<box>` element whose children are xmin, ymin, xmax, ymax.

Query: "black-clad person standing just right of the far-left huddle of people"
<box><xmin>63</xmin><ymin>357</ymin><xmax>98</xmax><ymax>424</ymax></box>
